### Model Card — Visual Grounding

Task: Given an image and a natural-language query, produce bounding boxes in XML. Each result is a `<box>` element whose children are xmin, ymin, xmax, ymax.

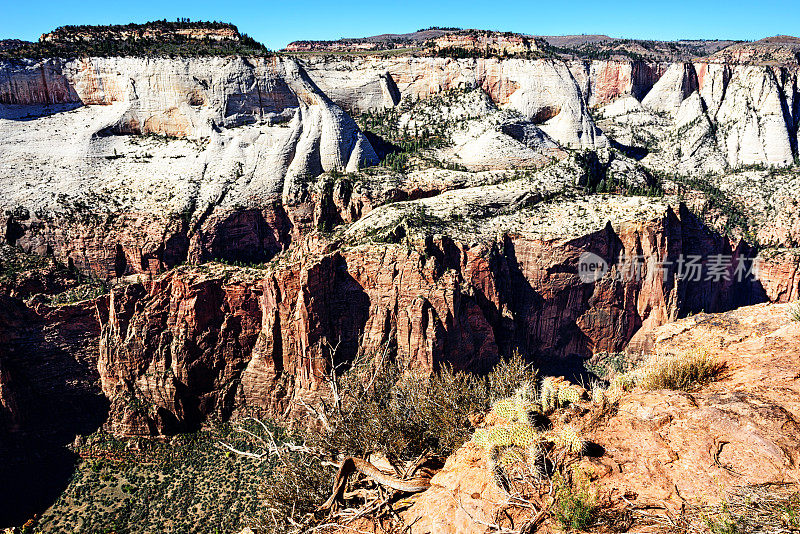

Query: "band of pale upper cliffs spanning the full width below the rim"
<box><xmin>0</xmin><ymin>57</ymin><xmax>800</xmax><ymax>167</ymax></box>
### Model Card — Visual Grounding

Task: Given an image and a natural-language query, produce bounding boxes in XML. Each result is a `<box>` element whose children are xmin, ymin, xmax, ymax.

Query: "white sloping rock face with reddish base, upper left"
<box><xmin>0</xmin><ymin>58</ymin><xmax>377</xmax><ymax>276</ymax></box>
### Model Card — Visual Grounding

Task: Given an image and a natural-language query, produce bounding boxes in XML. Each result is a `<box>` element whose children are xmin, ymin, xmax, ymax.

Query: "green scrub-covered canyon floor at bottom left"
<box><xmin>31</xmin><ymin>423</ymin><xmax>284</xmax><ymax>534</ymax></box>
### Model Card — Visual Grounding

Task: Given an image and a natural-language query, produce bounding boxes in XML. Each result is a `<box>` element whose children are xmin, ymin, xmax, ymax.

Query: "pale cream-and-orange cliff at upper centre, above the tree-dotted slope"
<box><xmin>304</xmin><ymin>57</ymin><xmax>608</xmax><ymax>148</ymax></box>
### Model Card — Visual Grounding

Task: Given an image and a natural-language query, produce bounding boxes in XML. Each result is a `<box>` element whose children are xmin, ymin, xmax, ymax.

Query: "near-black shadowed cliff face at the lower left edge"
<box><xmin>0</xmin><ymin>295</ymin><xmax>108</xmax><ymax>526</ymax></box>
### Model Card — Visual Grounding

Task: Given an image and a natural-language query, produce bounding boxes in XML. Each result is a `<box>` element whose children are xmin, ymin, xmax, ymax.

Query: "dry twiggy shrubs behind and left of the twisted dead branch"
<box><xmin>228</xmin><ymin>349</ymin><xmax>536</xmax><ymax>532</ymax></box>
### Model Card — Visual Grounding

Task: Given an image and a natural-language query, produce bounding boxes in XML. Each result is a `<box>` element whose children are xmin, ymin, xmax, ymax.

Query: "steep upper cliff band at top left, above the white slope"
<box><xmin>0</xmin><ymin>57</ymin><xmax>378</xmax><ymax>142</ymax></box>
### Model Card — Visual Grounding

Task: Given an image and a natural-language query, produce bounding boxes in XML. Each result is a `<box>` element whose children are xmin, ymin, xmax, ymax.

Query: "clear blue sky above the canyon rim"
<box><xmin>0</xmin><ymin>0</ymin><xmax>800</xmax><ymax>49</ymax></box>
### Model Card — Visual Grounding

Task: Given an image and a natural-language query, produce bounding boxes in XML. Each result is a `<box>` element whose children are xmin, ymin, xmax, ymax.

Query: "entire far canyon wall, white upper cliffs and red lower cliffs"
<box><xmin>0</xmin><ymin>52</ymin><xmax>800</xmax><ymax>444</ymax></box>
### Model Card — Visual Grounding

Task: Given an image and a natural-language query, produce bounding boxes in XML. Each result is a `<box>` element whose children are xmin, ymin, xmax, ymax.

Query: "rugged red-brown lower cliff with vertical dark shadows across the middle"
<box><xmin>99</xmin><ymin>203</ymin><xmax>763</xmax><ymax>435</ymax></box>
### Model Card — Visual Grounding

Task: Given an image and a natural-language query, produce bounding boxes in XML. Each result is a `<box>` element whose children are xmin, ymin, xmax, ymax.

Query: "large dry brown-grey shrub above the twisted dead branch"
<box><xmin>311</xmin><ymin>355</ymin><xmax>536</xmax><ymax>460</ymax></box>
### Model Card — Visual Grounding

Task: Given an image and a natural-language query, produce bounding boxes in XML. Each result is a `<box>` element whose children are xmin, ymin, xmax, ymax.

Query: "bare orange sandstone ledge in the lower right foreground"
<box><xmin>398</xmin><ymin>305</ymin><xmax>800</xmax><ymax>533</ymax></box>
